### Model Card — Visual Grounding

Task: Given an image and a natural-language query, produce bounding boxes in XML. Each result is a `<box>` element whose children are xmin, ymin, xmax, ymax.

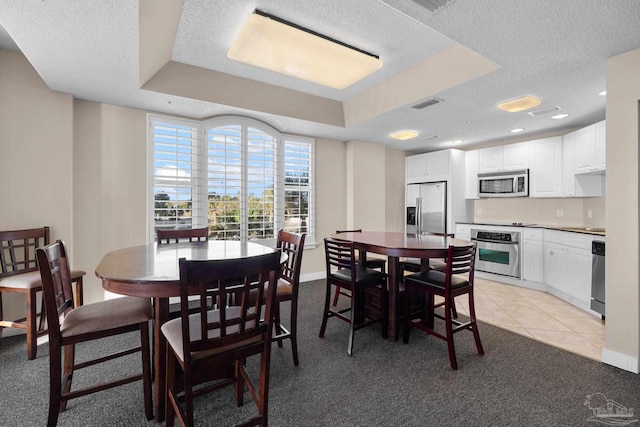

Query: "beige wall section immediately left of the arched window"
<box><xmin>73</xmin><ymin>101</ymin><xmax>148</xmax><ymax>302</ymax></box>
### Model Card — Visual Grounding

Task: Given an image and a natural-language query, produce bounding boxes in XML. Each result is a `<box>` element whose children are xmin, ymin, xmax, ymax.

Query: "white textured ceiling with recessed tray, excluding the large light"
<box><xmin>0</xmin><ymin>0</ymin><xmax>640</xmax><ymax>152</ymax></box>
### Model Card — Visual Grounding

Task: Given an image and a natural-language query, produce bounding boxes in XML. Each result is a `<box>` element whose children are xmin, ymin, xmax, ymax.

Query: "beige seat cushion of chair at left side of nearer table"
<box><xmin>60</xmin><ymin>297</ymin><xmax>153</xmax><ymax>338</ymax></box>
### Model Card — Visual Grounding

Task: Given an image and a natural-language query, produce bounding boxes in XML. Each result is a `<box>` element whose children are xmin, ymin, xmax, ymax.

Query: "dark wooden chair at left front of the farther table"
<box><xmin>320</xmin><ymin>238</ymin><xmax>389</xmax><ymax>356</ymax></box>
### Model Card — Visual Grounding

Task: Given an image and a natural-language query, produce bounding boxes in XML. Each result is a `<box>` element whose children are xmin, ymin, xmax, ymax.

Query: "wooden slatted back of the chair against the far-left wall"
<box><xmin>0</xmin><ymin>227</ymin><xmax>49</xmax><ymax>277</ymax></box>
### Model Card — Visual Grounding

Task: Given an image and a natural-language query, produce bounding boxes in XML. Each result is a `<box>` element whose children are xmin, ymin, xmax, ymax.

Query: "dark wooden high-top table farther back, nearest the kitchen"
<box><xmin>331</xmin><ymin>231</ymin><xmax>471</xmax><ymax>340</ymax></box>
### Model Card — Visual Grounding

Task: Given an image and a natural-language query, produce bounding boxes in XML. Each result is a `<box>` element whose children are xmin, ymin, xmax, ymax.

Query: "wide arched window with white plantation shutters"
<box><xmin>149</xmin><ymin>115</ymin><xmax>315</xmax><ymax>242</ymax></box>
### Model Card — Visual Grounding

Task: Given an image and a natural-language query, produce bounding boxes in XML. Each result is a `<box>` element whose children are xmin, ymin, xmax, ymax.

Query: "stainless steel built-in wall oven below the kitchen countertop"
<box><xmin>471</xmin><ymin>229</ymin><xmax>520</xmax><ymax>278</ymax></box>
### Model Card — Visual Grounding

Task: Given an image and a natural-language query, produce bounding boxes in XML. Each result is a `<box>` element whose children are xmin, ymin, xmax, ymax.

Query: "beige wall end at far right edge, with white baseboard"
<box><xmin>603</xmin><ymin>49</ymin><xmax>640</xmax><ymax>372</ymax></box>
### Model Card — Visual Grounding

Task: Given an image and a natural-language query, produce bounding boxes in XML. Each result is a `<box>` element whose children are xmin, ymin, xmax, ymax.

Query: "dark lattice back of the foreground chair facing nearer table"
<box><xmin>179</xmin><ymin>251</ymin><xmax>280</xmax><ymax>365</ymax></box>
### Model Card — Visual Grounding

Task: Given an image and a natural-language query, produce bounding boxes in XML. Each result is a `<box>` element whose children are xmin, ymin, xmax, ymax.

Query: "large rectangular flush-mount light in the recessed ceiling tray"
<box><xmin>227</xmin><ymin>10</ymin><xmax>382</xmax><ymax>89</ymax></box>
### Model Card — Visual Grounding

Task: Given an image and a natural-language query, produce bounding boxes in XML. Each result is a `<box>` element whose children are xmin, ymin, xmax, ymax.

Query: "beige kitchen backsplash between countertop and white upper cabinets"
<box><xmin>473</xmin><ymin>197</ymin><xmax>605</xmax><ymax>228</ymax></box>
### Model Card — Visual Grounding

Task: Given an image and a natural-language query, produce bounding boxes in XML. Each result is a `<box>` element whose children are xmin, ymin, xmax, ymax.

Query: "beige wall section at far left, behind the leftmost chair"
<box><xmin>0</xmin><ymin>50</ymin><xmax>77</xmax><ymax>319</ymax></box>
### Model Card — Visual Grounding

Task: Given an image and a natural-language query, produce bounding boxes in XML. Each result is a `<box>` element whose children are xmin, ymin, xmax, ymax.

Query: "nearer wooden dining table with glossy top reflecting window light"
<box><xmin>96</xmin><ymin>240</ymin><xmax>287</xmax><ymax>421</ymax></box>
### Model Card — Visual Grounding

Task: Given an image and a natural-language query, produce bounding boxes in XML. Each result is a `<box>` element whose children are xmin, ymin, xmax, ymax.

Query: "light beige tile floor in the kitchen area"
<box><xmin>456</xmin><ymin>278</ymin><xmax>604</xmax><ymax>361</ymax></box>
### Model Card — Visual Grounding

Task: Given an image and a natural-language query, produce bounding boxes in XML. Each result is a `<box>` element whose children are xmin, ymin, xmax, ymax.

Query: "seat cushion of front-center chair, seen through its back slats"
<box><xmin>161</xmin><ymin>306</ymin><xmax>262</xmax><ymax>361</ymax></box>
